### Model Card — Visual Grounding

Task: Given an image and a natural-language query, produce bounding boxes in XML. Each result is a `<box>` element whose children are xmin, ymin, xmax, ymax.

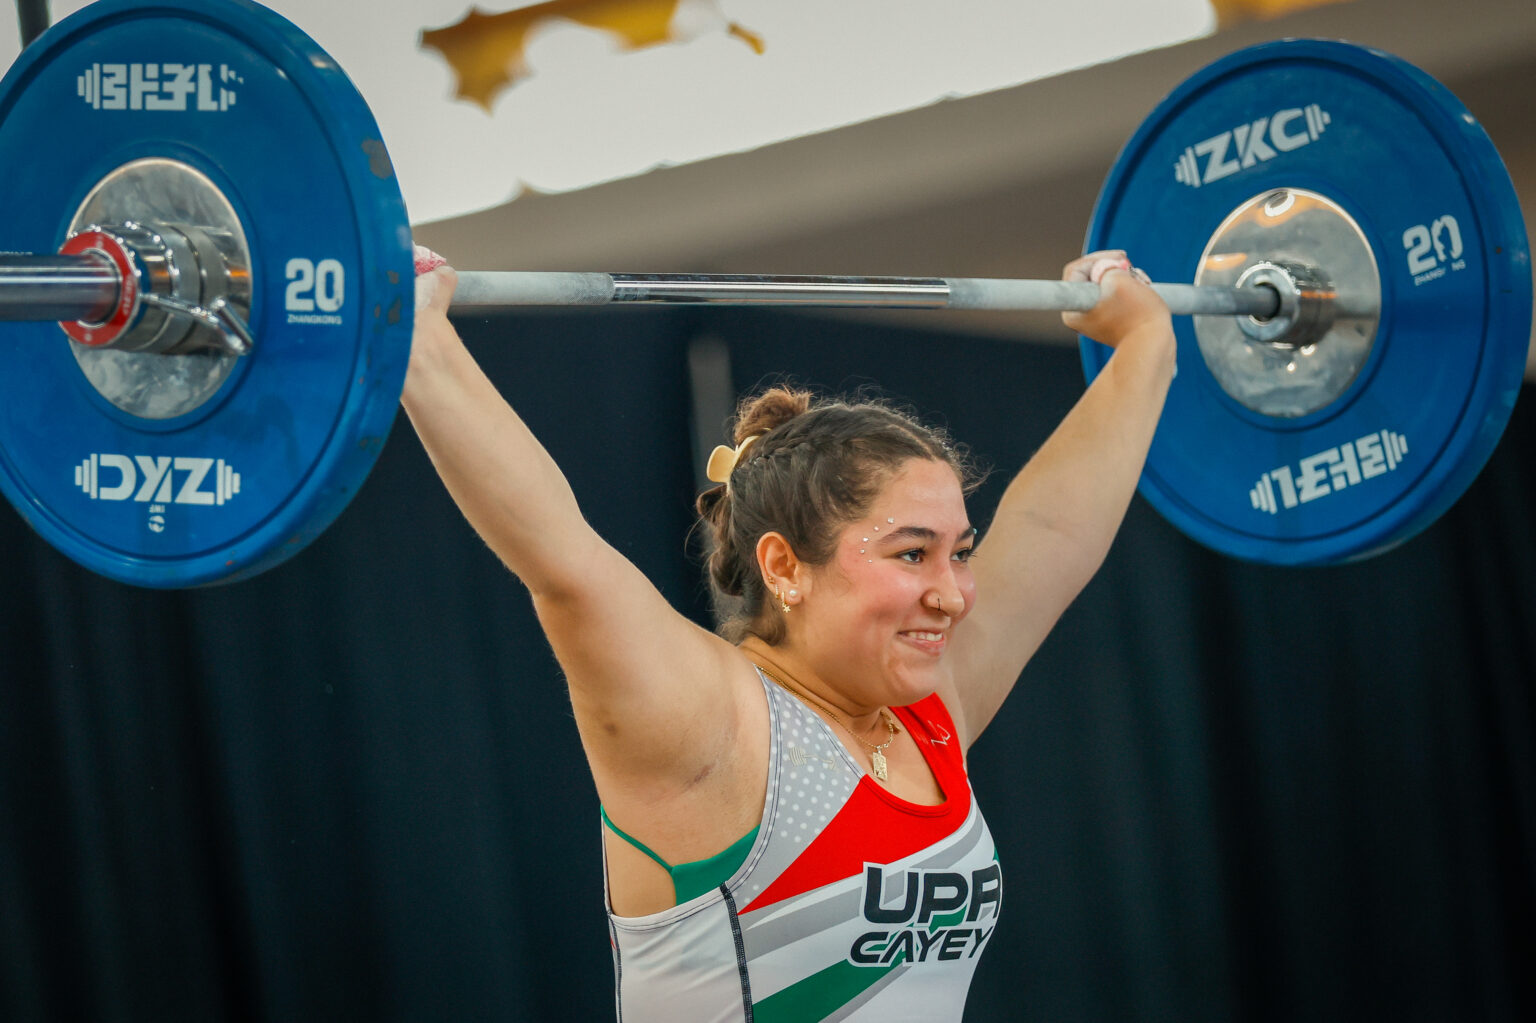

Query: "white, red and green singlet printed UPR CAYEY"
<box><xmin>608</xmin><ymin>671</ymin><xmax>1003</xmax><ymax>1023</ymax></box>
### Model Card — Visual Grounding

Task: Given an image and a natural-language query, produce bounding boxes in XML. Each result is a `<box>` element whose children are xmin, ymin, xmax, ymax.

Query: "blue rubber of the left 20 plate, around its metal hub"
<box><xmin>0</xmin><ymin>0</ymin><xmax>413</xmax><ymax>587</ymax></box>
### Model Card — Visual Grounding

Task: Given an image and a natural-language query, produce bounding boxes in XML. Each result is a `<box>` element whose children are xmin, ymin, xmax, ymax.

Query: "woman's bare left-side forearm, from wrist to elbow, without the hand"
<box><xmin>401</xmin><ymin>308</ymin><xmax>601</xmax><ymax>593</ymax></box>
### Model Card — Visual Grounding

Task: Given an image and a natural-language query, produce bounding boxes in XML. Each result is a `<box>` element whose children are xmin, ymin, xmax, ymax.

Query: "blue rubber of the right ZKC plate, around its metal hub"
<box><xmin>1083</xmin><ymin>40</ymin><xmax>1531</xmax><ymax>565</ymax></box>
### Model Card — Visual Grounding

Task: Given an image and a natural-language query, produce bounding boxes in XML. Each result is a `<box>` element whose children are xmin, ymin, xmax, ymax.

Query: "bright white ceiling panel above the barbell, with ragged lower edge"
<box><xmin>0</xmin><ymin>0</ymin><xmax>1215</xmax><ymax>223</ymax></box>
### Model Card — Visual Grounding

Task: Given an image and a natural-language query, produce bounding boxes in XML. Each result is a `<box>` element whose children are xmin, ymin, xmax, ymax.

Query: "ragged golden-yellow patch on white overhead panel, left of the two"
<box><xmin>421</xmin><ymin>0</ymin><xmax>763</xmax><ymax>112</ymax></box>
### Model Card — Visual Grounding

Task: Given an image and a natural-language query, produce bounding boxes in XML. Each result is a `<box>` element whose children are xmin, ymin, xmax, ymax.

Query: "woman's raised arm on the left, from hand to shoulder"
<box><xmin>401</xmin><ymin>267</ymin><xmax>760</xmax><ymax>808</ymax></box>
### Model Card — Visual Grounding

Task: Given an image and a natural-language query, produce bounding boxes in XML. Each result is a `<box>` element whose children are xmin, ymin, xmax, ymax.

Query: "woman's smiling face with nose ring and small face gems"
<box><xmin>788</xmin><ymin>458</ymin><xmax>975</xmax><ymax>707</ymax></box>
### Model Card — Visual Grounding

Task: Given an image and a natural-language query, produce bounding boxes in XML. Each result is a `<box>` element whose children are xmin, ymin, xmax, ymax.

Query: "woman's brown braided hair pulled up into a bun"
<box><xmin>694</xmin><ymin>386</ymin><xmax>980</xmax><ymax>644</ymax></box>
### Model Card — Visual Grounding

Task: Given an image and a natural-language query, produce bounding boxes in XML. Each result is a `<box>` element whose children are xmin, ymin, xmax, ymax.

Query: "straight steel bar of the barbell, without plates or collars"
<box><xmin>0</xmin><ymin>253</ymin><xmax>1345</xmax><ymax>323</ymax></box>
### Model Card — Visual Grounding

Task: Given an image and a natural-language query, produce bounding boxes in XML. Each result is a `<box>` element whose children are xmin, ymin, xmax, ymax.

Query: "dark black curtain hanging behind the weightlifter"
<box><xmin>0</xmin><ymin>310</ymin><xmax>1536</xmax><ymax>1023</ymax></box>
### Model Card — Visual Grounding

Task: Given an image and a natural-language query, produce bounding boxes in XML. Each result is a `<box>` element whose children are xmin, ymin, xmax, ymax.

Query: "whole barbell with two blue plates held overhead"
<box><xmin>0</xmin><ymin>0</ymin><xmax>1531</xmax><ymax>587</ymax></box>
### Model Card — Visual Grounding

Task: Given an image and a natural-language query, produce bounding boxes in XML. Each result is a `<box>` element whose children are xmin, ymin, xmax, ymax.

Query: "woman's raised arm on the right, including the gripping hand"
<box><xmin>954</xmin><ymin>252</ymin><xmax>1175</xmax><ymax>743</ymax></box>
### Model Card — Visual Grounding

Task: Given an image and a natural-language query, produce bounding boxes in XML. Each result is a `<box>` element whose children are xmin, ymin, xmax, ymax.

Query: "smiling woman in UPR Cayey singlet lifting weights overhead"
<box><xmin>402</xmin><ymin>252</ymin><xmax>1175</xmax><ymax>1023</ymax></box>
